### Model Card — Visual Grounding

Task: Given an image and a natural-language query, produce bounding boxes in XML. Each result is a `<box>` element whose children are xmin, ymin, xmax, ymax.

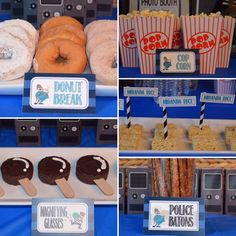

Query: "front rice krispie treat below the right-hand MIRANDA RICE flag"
<box><xmin>192</xmin><ymin>136</ymin><xmax>220</xmax><ymax>151</ymax></box>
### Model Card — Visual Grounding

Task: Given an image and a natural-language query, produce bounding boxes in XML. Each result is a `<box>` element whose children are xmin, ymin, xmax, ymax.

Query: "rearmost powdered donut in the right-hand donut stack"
<box><xmin>86</xmin><ymin>20</ymin><xmax>117</xmax><ymax>40</ymax></box>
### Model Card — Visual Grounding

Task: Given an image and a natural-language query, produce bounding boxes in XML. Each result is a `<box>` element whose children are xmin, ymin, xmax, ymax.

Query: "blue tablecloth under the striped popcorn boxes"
<box><xmin>119</xmin><ymin>57</ymin><xmax>236</xmax><ymax>78</ymax></box>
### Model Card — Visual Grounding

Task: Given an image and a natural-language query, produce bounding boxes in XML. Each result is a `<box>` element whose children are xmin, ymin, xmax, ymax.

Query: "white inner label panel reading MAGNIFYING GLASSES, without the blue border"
<box><xmin>37</xmin><ymin>202</ymin><xmax>88</xmax><ymax>234</ymax></box>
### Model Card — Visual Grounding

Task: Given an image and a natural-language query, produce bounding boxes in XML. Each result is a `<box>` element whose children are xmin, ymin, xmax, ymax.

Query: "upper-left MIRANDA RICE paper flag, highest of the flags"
<box><xmin>124</xmin><ymin>87</ymin><xmax>158</xmax><ymax>97</ymax></box>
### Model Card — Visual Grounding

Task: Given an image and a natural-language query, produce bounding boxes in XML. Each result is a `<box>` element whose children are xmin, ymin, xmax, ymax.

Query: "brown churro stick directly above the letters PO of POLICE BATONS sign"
<box><xmin>170</xmin><ymin>158</ymin><xmax>180</xmax><ymax>197</ymax></box>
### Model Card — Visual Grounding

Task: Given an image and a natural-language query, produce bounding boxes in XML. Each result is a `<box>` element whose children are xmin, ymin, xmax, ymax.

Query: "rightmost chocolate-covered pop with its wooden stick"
<box><xmin>76</xmin><ymin>155</ymin><xmax>114</xmax><ymax>196</ymax></box>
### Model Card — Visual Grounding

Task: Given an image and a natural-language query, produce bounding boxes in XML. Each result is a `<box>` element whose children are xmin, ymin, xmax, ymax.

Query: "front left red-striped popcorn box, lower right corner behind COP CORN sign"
<box><xmin>135</xmin><ymin>16</ymin><xmax>174</xmax><ymax>74</ymax></box>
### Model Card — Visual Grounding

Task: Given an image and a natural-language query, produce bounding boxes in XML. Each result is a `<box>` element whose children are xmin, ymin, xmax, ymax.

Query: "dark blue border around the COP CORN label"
<box><xmin>156</xmin><ymin>48</ymin><xmax>200</xmax><ymax>77</ymax></box>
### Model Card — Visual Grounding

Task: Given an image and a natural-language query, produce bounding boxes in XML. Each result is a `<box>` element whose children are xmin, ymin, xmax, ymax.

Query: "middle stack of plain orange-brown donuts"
<box><xmin>33</xmin><ymin>16</ymin><xmax>87</xmax><ymax>74</ymax></box>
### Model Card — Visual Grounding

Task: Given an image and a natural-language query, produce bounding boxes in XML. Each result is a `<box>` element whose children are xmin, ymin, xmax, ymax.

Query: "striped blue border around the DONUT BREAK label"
<box><xmin>22</xmin><ymin>73</ymin><xmax>96</xmax><ymax>114</ymax></box>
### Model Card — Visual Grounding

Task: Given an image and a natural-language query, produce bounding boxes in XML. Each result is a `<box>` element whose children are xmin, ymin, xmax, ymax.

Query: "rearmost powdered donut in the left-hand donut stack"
<box><xmin>0</xmin><ymin>19</ymin><xmax>39</xmax><ymax>45</ymax></box>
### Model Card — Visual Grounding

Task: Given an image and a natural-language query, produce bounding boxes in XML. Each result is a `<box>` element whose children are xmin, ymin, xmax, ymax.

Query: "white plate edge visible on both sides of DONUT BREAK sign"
<box><xmin>0</xmin><ymin>78</ymin><xmax>117</xmax><ymax>97</ymax></box>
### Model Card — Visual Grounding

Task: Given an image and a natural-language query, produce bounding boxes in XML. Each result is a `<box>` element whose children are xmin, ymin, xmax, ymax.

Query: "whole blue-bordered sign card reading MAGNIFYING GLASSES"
<box><xmin>32</xmin><ymin>198</ymin><xmax>94</xmax><ymax>236</ymax></box>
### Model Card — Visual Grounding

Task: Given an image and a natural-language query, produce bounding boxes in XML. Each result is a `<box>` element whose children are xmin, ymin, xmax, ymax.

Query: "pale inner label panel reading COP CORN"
<box><xmin>160</xmin><ymin>51</ymin><xmax>196</xmax><ymax>73</ymax></box>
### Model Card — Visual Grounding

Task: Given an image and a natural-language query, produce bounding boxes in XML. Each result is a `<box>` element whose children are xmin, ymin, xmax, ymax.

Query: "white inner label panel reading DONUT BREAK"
<box><xmin>29</xmin><ymin>77</ymin><xmax>89</xmax><ymax>110</ymax></box>
